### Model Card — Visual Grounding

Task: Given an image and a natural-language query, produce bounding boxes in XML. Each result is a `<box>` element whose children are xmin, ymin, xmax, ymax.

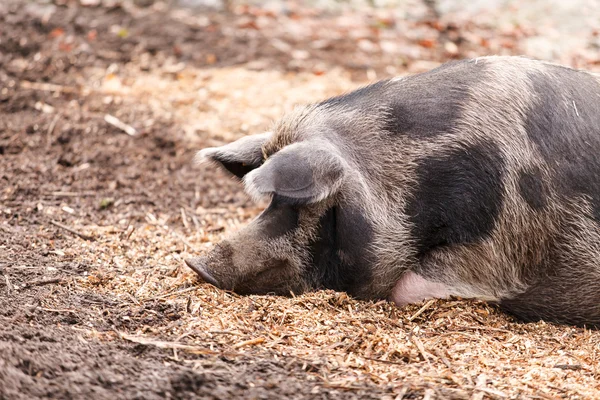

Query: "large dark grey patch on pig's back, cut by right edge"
<box><xmin>525</xmin><ymin>66</ymin><xmax>600</xmax><ymax>222</ymax></box>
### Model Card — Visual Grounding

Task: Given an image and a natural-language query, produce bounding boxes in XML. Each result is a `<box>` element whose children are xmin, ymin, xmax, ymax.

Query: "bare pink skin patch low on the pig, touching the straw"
<box><xmin>390</xmin><ymin>271</ymin><xmax>450</xmax><ymax>306</ymax></box>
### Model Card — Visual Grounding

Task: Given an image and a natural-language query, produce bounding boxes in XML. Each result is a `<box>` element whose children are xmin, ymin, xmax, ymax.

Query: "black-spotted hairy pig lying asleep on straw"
<box><xmin>187</xmin><ymin>56</ymin><xmax>600</xmax><ymax>327</ymax></box>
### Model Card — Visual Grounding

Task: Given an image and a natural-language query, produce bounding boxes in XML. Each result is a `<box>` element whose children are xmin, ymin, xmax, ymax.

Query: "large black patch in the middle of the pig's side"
<box><xmin>406</xmin><ymin>141</ymin><xmax>505</xmax><ymax>256</ymax></box>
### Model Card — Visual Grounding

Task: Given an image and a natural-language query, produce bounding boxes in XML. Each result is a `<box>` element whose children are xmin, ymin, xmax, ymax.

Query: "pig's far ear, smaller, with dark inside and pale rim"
<box><xmin>195</xmin><ymin>132</ymin><xmax>272</xmax><ymax>178</ymax></box>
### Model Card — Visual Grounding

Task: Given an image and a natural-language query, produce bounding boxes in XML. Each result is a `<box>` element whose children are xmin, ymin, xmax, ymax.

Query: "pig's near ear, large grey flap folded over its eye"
<box><xmin>244</xmin><ymin>141</ymin><xmax>344</xmax><ymax>204</ymax></box>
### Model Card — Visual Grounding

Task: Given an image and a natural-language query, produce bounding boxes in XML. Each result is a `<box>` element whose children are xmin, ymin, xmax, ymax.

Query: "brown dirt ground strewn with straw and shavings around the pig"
<box><xmin>0</xmin><ymin>0</ymin><xmax>600</xmax><ymax>399</ymax></box>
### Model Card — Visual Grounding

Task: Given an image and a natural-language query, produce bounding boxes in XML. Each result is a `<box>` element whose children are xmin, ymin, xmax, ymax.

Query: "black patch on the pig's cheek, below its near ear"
<box><xmin>310</xmin><ymin>207</ymin><xmax>373</xmax><ymax>297</ymax></box>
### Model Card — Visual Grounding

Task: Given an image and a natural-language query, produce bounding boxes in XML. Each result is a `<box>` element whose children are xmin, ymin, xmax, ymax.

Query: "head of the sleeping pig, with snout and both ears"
<box><xmin>186</xmin><ymin>126</ymin><xmax>372</xmax><ymax>297</ymax></box>
